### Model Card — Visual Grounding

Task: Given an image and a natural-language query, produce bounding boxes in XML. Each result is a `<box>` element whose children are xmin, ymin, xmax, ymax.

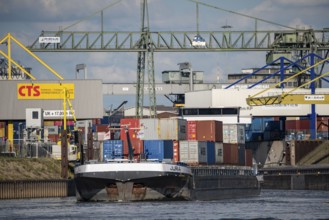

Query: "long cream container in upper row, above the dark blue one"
<box><xmin>139</xmin><ymin>118</ymin><xmax>186</xmax><ymax>140</ymax></box>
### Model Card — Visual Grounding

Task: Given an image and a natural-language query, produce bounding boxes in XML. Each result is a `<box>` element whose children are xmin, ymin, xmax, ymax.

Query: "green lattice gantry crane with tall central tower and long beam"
<box><xmin>25</xmin><ymin>0</ymin><xmax>329</xmax><ymax>117</ymax></box>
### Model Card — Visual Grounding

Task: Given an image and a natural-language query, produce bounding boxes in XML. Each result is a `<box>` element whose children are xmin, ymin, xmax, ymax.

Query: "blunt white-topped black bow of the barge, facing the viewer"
<box><xmin>75</xmin><ymin>160</ymin><xmax>192</xmax><ymax>202</ymax></box>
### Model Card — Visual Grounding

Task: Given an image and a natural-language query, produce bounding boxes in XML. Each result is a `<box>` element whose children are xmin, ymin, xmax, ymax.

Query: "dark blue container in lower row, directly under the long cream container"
<box><xmin>144</xmin><ymin>140</ymin><xmax>174</xmax><ymax>161</ymax></box>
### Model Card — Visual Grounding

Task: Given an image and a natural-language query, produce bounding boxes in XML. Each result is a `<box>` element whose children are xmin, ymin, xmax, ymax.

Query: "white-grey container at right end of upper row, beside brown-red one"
<box><xmin>223</xmin><ymin>124</ymin><xmax>246</xmax><ymax>144</ymax></box>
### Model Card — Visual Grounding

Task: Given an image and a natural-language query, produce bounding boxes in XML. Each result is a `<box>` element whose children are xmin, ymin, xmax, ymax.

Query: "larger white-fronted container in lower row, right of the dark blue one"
<box><xmin>179</xmin><ymin>141</ymin><xmax>207</xmax><ymax>164</ymax></box>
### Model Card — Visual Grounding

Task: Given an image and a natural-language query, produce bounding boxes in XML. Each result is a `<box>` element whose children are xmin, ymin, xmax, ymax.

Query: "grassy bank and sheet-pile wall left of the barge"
<box><xmin>0</xmin><ymin>157</ymin><xmax>75</xmax><ymax>199</ymax></box>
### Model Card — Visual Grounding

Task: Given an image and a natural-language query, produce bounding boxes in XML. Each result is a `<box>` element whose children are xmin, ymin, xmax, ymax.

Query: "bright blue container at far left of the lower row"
<box><xmin>103</xmin><ymin>140</ymin><xmax>123</xmax><ymax>161</ymax></box>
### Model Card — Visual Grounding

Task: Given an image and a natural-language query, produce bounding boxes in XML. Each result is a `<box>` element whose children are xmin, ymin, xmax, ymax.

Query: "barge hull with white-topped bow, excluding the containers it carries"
<box><xmin>75</xmin><ymin>160</ymin><xmax>260</xmax><ymax>202</ymax></box>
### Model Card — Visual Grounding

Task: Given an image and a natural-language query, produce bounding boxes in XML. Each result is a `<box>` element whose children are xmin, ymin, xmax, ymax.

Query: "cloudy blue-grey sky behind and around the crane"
<box><xmin>0</xmin><ymin>0</ymin><xmax>329</xmax><ymax>108</ymax></box>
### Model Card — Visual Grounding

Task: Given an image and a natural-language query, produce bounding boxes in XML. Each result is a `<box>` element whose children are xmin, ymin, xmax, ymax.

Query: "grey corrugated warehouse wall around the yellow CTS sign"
<box><xmin>0</xmin><ymin>80</ymin><xmax>103</xmax><ymax>120</ymax></box>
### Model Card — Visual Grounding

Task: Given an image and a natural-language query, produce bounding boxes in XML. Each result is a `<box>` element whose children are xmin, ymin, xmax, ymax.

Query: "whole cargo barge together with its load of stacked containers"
<box><xmin>75</xmin><ymin>119</ymin><xmax>260</xmax><ymax>201</ymax></box>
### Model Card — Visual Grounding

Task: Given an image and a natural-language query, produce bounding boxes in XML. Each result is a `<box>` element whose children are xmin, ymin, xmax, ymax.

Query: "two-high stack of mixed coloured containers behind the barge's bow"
<box><xmin>98</xmin><ymin>118</ymin><xmax>252</xmax><ymax>166</ymax></box>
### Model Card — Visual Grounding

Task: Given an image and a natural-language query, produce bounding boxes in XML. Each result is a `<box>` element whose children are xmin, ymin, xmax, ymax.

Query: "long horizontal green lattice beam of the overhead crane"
<box><xmin>28</xmin><ymin>29</ymin><xmax>329</xmax><ymax>52</ymax></box>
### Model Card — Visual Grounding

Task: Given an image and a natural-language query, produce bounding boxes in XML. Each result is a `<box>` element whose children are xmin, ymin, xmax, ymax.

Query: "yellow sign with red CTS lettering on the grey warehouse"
<box><xmin>17</xmin><ymin>83</ymin><xmax>74</xmax><ymax>99</ymax></box>
